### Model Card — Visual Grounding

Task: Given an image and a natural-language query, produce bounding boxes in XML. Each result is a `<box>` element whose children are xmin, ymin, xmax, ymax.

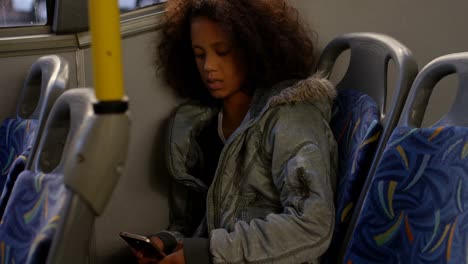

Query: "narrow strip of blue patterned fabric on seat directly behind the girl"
<box><xmin>323</xmin><ymin>89</ymin><xmax>382</xmax><ymax>263</ymax></box>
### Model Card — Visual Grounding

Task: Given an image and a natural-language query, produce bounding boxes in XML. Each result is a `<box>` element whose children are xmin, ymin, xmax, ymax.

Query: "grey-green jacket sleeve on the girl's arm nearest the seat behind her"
<box><xmin>210</xmin><ymin>103</ymin><xmax>336</xmax><ymax>263</ymax></box>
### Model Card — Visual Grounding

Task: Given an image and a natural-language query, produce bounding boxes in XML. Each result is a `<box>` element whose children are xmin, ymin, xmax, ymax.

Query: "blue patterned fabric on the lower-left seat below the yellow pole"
<box><xmin>0</xmin><ymin>171</ymin><xmax>69</xmax><ymax>264</ymax></box>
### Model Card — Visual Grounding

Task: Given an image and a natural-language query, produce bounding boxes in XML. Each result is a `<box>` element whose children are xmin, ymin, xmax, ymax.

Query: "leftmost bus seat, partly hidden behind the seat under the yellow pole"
<box><xmin>0</xmin><ymin>55</ymin><xmax>69</xmax><ymax>217</ymax></box>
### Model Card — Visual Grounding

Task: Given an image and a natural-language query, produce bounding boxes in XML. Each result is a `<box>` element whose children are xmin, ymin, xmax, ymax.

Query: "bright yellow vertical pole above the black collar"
<box><xmin>88</xmin><ymin>0</ymin><xmax>124</xmax><ymax>101</ymax></box>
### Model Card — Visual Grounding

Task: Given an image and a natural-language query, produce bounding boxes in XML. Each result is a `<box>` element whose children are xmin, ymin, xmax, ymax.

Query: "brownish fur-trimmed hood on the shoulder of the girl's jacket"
<box><xmin>251</xmin><ymin>73</ymin><xmax>336</xmax><ymax>119</ymax></box>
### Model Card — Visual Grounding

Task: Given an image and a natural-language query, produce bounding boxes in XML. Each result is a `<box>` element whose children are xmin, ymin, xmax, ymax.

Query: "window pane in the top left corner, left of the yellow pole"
<box><xmin>0</xmin><ymin>0</ymin><xmax>47</xmax><ymax>27</ymax></box>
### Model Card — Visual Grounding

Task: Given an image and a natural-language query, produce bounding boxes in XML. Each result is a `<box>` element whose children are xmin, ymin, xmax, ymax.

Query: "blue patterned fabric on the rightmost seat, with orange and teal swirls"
<box><xmin>345</xmin><ymin>127</ymin><xmax>468</xmax><ymax>264</ymax></box>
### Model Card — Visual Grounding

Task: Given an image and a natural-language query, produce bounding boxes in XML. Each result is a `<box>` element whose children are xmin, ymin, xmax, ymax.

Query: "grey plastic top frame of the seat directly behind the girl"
<box><xmin>317</xmin><ymin>33</ymin><xmax>418</xmax><ymax>143</ymax></box>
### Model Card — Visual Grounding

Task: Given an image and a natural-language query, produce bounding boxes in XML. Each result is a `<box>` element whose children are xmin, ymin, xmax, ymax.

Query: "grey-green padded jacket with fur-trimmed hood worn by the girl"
<box><xmin>163</xmin><ymin>76</ymin><xmax>337</xmax><ymax>263</ymax></box>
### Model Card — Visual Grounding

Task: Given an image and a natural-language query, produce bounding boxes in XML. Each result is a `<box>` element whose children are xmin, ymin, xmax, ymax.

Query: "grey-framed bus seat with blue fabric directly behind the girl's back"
<box><xmin>318</xmin><ymin>33</ymin><xmax>417</xmax><ymax>263</ymax></box>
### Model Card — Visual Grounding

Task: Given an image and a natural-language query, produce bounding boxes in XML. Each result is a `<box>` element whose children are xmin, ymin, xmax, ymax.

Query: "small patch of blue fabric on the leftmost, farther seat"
<box><xmin>0</xmin><ymin>119</ymin><xmax>38</xmax><ymax>190</ymax></box>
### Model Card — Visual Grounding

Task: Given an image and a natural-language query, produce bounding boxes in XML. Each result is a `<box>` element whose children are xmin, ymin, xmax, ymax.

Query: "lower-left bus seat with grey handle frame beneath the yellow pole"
<box><xmin>0</xmin><ymin>88</ymin><xmax>129</xmax><ymax>263</ymax></box>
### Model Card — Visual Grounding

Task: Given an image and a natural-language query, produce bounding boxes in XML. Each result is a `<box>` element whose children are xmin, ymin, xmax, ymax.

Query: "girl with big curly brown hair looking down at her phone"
<box><xmin>135</xmin><ymin>0</ymin><xmax>337</xmax><ymax>263</ymax></box>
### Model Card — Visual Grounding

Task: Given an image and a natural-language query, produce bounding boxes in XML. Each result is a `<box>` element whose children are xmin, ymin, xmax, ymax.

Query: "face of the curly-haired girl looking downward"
<box><xmin>191</xmin><ymin>17</ymin><xmax>246</xmax><ymax>100</ymax></box>
